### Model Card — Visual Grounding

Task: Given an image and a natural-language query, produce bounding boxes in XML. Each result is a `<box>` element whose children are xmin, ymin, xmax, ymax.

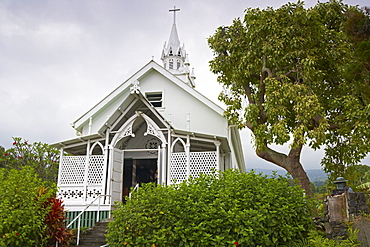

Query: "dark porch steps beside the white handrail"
<box><xmin>73</xmin><ymin>220</ymin><xmax>108</xmax><ymax>247</ymax></box>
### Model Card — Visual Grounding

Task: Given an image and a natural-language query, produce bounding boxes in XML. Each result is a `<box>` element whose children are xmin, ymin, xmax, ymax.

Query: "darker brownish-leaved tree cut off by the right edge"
<box><xmin>322</xmin><ymin>7</ymin><xmax>370</xmax><ymax>183</ymax></box>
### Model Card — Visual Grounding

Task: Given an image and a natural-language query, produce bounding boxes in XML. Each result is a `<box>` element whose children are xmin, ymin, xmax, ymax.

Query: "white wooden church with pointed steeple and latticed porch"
<box><xmin>53</xmin><ymin>9</ymin><xmax>245</xmax><ymax>224</ymax></box>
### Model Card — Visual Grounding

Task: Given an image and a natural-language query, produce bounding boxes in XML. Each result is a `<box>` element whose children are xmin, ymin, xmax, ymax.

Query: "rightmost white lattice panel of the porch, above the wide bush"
<box><xmin>190</xmin><ymin>152</ymin><xmax>218</xmax><ymax>178</ymax></box>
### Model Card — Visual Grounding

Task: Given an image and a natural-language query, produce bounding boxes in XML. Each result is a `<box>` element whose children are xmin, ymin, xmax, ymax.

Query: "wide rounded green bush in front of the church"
<box><xmin>107</xmin><ymin>170</ymin><xmax>311</xmax><ymax>247</ymax></box>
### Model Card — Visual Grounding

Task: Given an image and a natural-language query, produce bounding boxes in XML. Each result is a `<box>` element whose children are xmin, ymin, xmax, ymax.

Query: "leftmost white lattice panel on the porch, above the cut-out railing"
<box><xmin>60</xmin><ymin>156</ymin><xmax>86</xmax><ymax>184</ymax></box>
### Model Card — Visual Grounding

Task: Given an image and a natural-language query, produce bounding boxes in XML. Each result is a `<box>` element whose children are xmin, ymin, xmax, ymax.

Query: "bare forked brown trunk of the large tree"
<box><xmin>256</xmin><ymin>146</ymin><xmax>313</xmax><ymax>196</ymax></box>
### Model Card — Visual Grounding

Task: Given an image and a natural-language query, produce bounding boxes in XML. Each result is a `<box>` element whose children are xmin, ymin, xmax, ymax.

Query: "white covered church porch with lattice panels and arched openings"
<box><xmin>58</xmin><ymin>131</ymin><xmax>230</xmax><ymax>211</ymax></box>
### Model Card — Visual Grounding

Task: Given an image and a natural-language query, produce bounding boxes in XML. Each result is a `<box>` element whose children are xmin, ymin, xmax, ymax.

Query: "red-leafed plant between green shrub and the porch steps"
<box><xmin>45</xmin><ymin>197</ymin><xmax>73</xmax><ymax>246</ymax></box>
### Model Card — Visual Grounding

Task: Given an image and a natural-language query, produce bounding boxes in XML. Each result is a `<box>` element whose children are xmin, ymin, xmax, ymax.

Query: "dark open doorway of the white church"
<box><xmin>123</xmin><ymin>159</ymin><xmax>158</xmax><ymax>196</ymax></box>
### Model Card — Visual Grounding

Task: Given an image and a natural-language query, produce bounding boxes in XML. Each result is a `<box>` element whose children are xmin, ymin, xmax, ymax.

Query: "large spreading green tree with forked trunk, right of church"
<box><xmin>208</xmin><ymin>1</ymin><xmax>370</xmax><ymax>194</ymax></box>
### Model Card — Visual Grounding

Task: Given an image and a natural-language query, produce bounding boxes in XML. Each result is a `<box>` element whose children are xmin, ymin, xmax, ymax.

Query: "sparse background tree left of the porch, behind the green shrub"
<box><xmin>0</xmin><ymin>137</ymin><xmax>60</xmax><ymax>183</ymax></box>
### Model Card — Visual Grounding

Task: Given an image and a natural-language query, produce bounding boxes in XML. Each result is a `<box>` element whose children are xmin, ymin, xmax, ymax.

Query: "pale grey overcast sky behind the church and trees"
<box><xmin>0</xmin><ymin>0</ymin><xmax>370</xmax><ymax>171</ymax></box>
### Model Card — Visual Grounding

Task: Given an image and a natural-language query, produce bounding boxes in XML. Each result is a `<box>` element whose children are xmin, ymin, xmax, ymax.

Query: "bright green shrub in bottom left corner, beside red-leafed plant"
<box><xmin>0</xmin><ymin>167</ymin><xmax>55</xmax><ymax>246</ymax></box>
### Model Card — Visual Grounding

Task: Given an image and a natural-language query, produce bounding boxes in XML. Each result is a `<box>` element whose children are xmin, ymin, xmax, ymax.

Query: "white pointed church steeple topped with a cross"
<box><xmin>161</xmin><ymin>7</ymin><xmax>195</xmax><ymax>87</ymax></box>
